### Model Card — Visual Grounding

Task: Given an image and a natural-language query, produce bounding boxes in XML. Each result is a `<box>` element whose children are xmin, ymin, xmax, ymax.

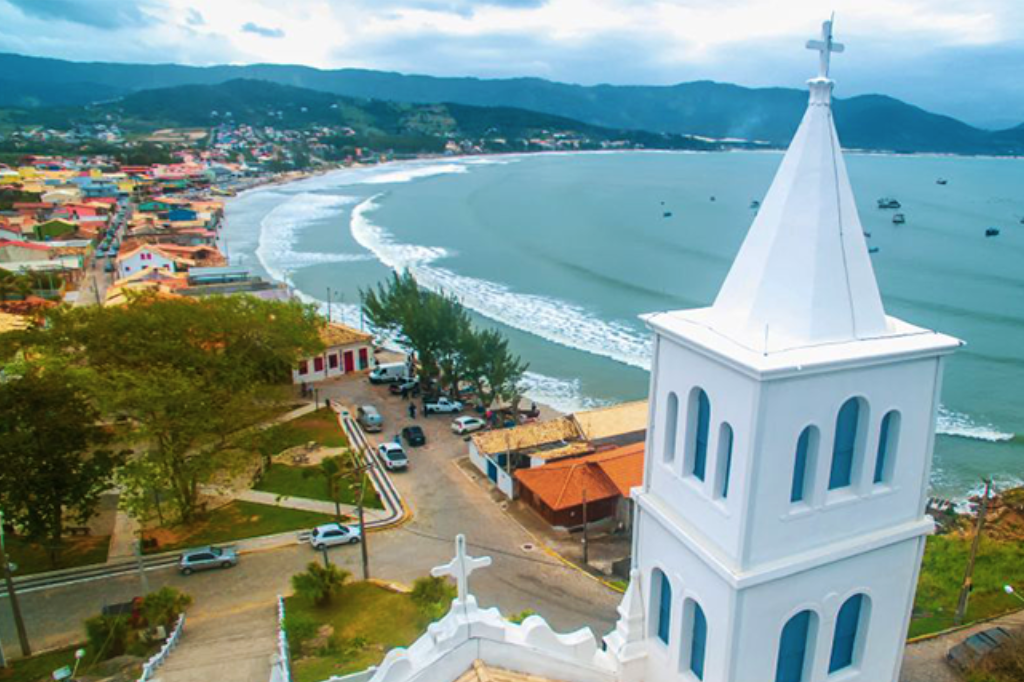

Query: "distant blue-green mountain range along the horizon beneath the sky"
<box><xmin>0</xmin><ymin>54</ymin><xmax>1024</xmax><ymax>155</ymax></box>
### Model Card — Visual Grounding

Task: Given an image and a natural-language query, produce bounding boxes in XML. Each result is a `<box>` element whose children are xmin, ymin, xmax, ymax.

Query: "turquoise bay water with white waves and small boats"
<box><xmin>225</xmin><ymin>153</ymin><xmax>1024</xmax><ymax>498</ymax></box>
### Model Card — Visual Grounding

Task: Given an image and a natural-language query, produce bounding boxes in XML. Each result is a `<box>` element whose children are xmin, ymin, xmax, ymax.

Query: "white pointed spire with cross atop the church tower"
<box><xmin>712</xmin><ymin>22</ymin><xmax>888</xmax><ymax>353</ymax></box>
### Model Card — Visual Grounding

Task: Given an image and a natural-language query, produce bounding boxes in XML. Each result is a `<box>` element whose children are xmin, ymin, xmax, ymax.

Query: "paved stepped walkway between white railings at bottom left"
<box><xmin>154</xmin><ymin>602</ymin><xmax>278</xmax><ymax>682</ymax></box>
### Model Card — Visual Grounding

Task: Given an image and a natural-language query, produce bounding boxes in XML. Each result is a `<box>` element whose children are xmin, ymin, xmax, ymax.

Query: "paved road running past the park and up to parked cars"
<box><xmin>0</xmin><ymin>380</ymin><xmax>618</xmax><ymax>653</ymax></box>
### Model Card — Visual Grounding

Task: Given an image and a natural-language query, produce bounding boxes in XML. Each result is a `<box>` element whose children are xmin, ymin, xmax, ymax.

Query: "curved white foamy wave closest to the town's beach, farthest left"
<box><xmin>256</xmin><ymin>193</ymin><xmax>373</xmax><ymax>285</ymax></box>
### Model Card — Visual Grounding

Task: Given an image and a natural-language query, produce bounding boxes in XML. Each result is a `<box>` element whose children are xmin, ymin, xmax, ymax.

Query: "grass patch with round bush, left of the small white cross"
<box><xmin>285</xmin><ymin>583</ymin><xmax>430</xmax><ymax>682</ymax></box>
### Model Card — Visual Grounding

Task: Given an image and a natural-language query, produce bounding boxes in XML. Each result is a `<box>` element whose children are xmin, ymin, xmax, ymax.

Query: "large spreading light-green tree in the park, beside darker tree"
<box><xmin>20</xmin><ymin>296</ymin><xmax>323</xmax><ymax>522</ymax></box>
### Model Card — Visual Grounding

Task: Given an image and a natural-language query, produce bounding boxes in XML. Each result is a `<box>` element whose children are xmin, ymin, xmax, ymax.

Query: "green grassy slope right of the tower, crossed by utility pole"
<box><xmin>909</xmin><ymin>535</ymin><xmax>1024</xmax><ymax>637</ymax></box>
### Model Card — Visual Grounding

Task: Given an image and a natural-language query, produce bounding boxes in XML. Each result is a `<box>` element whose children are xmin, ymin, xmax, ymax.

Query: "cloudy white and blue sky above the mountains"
<box><xmin>0</xmin><ymin>0</ymin><xmax>1024</xmax><ymax>127</ymax></box>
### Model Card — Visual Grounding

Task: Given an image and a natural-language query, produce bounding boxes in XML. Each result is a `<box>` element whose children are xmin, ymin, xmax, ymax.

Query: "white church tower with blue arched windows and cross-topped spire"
<box><xmin>623</xmin><ymin>23</ymin><xmax>961</xmax><ymax>682</ymax></box>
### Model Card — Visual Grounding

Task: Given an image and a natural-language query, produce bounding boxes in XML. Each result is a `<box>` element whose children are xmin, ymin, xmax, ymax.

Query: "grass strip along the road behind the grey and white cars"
<box><xmin>145</xmin><ymin>501</ymin><xmax>335</xmax><ymax>553</ymax></box>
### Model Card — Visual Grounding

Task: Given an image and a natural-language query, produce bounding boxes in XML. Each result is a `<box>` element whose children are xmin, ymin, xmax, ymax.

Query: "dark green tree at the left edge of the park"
<box><xmin>0</xmin><ymin>369</ymin><xmax>121</xmax><ymax>565</ymax></box>
